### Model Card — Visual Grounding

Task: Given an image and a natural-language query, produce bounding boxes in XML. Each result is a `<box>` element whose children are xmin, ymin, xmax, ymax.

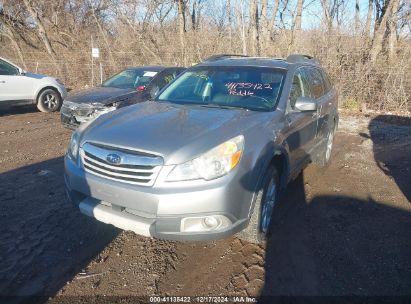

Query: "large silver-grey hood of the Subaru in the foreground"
<box><xmin>81</xmin><ymin>102</ymin><xmax>267</xmax><ymax>164</ymax></box>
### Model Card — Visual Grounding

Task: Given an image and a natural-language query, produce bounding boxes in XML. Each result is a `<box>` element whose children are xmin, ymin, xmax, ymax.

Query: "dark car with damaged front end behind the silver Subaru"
<box><xmin>61</xmin><ymin>66</ymin><xmax>184</xmax><ymax>129</ymax></box>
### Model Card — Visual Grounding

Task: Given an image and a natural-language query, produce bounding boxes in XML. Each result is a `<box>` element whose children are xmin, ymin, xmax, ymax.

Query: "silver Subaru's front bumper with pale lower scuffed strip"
<box><xmin>65</xmin><ymin>156</ymin><xmax>253</xmax><ymax>240</ymax></box>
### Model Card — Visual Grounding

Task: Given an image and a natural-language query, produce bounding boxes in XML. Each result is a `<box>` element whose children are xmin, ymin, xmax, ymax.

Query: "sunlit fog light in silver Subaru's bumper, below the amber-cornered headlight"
<box><xmin>180</xmin><ymin>215</ymin><xmax>231</xmax><ymax>232</ymax></box>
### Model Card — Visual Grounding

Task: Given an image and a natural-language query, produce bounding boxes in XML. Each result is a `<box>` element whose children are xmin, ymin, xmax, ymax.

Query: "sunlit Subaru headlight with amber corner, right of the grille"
<box><xmin>167</xmin><ymin>135</ymin><xmax>244</xmax><ymax>181</ymax></box>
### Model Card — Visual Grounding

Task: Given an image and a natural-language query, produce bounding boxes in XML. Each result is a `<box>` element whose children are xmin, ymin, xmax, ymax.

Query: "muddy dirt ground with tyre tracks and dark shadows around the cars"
<box><xmin>0</xmin><ymin>108</ymin><xmax>411</xmax><ymax>303</ymax></box>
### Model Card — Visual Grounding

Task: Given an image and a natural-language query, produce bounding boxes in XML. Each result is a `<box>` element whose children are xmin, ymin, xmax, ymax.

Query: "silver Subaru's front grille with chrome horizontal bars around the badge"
<box><xmin>80</xmin><ymin>143</ymin><xmax>163</xmax><ymax>186</ymax></box>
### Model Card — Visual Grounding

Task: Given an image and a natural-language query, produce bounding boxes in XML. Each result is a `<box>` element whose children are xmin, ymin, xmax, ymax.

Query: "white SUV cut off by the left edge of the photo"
<box><xmin>0</xmin><ymin>57</ymin><xmax>67</xmax><ymax>112</ymax></box>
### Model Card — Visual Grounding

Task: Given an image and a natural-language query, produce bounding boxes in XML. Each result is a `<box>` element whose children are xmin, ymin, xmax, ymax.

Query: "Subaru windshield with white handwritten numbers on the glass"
<box><xmin>156</xmin><ymin>66</ymin><xmax>285</xmax><ymax>111</ymax></box>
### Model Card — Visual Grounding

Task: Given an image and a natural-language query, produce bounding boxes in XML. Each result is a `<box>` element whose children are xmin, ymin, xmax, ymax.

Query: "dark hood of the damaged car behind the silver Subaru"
<box><xmin>66</xmin><ymin>87</ymin><xmax>136</xmax><ymax>105</ymax></box>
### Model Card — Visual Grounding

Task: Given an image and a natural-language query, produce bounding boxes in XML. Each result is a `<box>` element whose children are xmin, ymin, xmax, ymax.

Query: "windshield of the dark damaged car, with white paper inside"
<box><xmin>101</xmin><ymin>69</ymin><xmax>157</xmax><ymax>89</ymax></box>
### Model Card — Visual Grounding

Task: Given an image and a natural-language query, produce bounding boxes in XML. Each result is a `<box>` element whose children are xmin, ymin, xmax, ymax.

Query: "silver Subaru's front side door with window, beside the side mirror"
<box><xmin>286</xmin><ymin>68</ymin><xmax>317</xmax><ymax>168</ymax></box>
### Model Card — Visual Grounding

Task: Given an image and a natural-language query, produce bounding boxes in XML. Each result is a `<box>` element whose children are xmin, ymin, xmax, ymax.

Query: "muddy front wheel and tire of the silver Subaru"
<box><xmin>238</xmin><ymin>166</ymin><xmax>280</xmax><ymax>244</ymax></box>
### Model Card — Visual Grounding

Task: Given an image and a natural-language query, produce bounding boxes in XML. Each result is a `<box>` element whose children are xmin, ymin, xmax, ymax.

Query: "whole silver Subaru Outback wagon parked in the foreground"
<box><xmin>65</xmin><ymin>55</ymin><xmax>338</xmax><ymax>242</ymax></box>
